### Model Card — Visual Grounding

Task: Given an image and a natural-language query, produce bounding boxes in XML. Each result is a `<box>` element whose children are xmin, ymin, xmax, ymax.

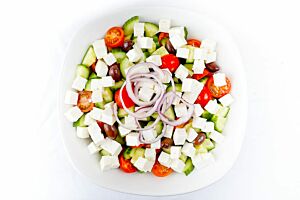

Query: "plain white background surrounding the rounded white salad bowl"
<box><xmin>0</xmin><ymin>0</ymin><xmax>300</xmax><ymax>200</ymax></box>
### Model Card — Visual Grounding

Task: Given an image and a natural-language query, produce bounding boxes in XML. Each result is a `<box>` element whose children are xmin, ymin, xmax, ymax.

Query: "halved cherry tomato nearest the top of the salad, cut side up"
<box><xmin>104</xmin><ymin>27</ymin><xmax>124</xmax><ymax>48</ymax></box>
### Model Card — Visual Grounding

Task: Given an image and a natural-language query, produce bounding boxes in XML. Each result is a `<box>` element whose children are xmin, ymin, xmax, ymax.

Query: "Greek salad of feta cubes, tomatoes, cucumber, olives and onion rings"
<box><xmin>65</xmin><ymin>16</ymin><xmax>233</xmax><ymax>177</ymax></box>
